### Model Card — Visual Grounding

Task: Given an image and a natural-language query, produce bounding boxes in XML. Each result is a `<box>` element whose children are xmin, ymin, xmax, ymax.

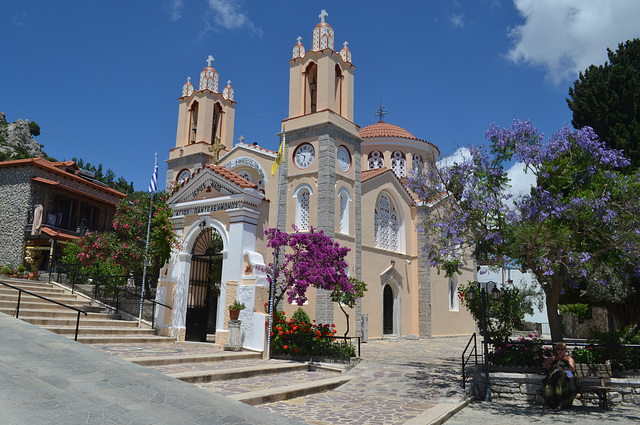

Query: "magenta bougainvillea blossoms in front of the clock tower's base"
<box><xmin>265</xmin><ymin>227</ymin><xmax>355</xmax><ymax>306</ymax></box>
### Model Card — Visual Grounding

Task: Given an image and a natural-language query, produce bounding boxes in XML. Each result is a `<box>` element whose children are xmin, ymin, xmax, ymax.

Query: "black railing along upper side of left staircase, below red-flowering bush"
<box><xmin>49</xmin><ymin>263</ymin><xmax>172</xmax><ymax>328</ymax></box>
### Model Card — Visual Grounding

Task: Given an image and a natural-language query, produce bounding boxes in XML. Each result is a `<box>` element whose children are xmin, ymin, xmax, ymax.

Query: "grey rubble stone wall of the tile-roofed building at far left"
<box><xmin>0</xmin><ymin>167</ymin><xmax>32</xmax><ymax>267</ymax></box>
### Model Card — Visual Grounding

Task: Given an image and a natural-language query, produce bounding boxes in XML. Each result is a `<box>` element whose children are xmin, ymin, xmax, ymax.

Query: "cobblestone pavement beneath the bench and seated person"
<box><xmin>447</xmin><ymin>402</ymin><xmax>640</xmax><ymax>425</ymax></box>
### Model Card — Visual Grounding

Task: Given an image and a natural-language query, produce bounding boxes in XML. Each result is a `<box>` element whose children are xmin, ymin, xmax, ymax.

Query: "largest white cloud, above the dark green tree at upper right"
<box><xmin>507</xmin><ymin>0</ymin><xmax>640</xmax><ymax>84</ymax></box>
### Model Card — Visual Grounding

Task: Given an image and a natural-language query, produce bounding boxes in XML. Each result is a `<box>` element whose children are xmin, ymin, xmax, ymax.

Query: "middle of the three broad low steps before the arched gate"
<box><xmin>167</xmin><ymin>363</ymin><xmax>309</xmax><ymax>384</ymax></box>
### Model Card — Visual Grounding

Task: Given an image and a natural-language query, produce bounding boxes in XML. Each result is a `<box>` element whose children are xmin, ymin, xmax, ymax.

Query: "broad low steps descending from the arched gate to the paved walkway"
<box><xmin>125</xmin><ymin>352</ymin><xmax>351</xmax><ymax>406</ymax></box>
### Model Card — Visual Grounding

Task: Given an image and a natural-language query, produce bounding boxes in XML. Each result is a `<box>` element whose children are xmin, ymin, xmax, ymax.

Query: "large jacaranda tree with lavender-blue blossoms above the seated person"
<box><xmin>410</xmin><ymin>120</ymin><xmax>640</xmax><ymax>341</ymax></box>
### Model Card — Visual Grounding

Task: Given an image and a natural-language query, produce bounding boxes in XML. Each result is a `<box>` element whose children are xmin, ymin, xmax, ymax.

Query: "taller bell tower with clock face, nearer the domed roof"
<box><xmin>278</xmin><ymin>10</ymin><xmax>362</xmax><ymax>324</ymax></box>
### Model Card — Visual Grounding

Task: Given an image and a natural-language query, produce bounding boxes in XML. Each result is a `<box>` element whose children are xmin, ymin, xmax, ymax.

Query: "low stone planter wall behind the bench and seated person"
<box><xmin>473</xmin><ymin>371</ymin><xmax>640</xmax><ymax>407</ymax></box>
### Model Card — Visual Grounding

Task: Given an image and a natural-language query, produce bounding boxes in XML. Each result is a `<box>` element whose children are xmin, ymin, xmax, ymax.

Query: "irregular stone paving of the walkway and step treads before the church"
<box><xmin>96</xmin><ymin>336</ymin><xmax>468</xmax><ymax>424</ymax></box>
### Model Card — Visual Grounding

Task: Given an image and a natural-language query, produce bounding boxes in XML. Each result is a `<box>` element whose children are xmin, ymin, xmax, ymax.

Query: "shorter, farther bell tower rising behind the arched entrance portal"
<box><xmin>167</xmin><ymin>55</ymin><xmax>236</xmax><ymax>187</ymax></box>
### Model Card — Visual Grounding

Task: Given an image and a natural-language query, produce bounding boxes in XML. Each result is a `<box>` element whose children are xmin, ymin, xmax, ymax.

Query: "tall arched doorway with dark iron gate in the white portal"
<box><xmin>185</xmin><ymin>227</ymin><xmax>223</xmax><ymax>341</ymax></box>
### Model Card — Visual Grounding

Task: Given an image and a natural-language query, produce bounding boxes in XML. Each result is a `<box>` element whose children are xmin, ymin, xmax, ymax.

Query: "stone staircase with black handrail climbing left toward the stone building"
<box><xmin>0</xmin><ymin>279</ymin><xmax>173</xmax><ymax>344</ymax></box>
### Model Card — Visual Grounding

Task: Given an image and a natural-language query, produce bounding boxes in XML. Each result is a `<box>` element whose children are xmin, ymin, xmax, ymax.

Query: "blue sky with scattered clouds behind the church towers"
<box><xmin>0</xmin><ymin>0</ymin><xmax>640</xmax><ymax>190</ymax></box>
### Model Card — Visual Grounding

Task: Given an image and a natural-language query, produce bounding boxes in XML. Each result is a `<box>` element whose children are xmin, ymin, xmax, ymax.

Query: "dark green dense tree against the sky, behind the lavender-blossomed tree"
<box><xmin>567</xmin><ymin>38</ymin><xmax>640</xmax><ymax>169</ymax></box>
